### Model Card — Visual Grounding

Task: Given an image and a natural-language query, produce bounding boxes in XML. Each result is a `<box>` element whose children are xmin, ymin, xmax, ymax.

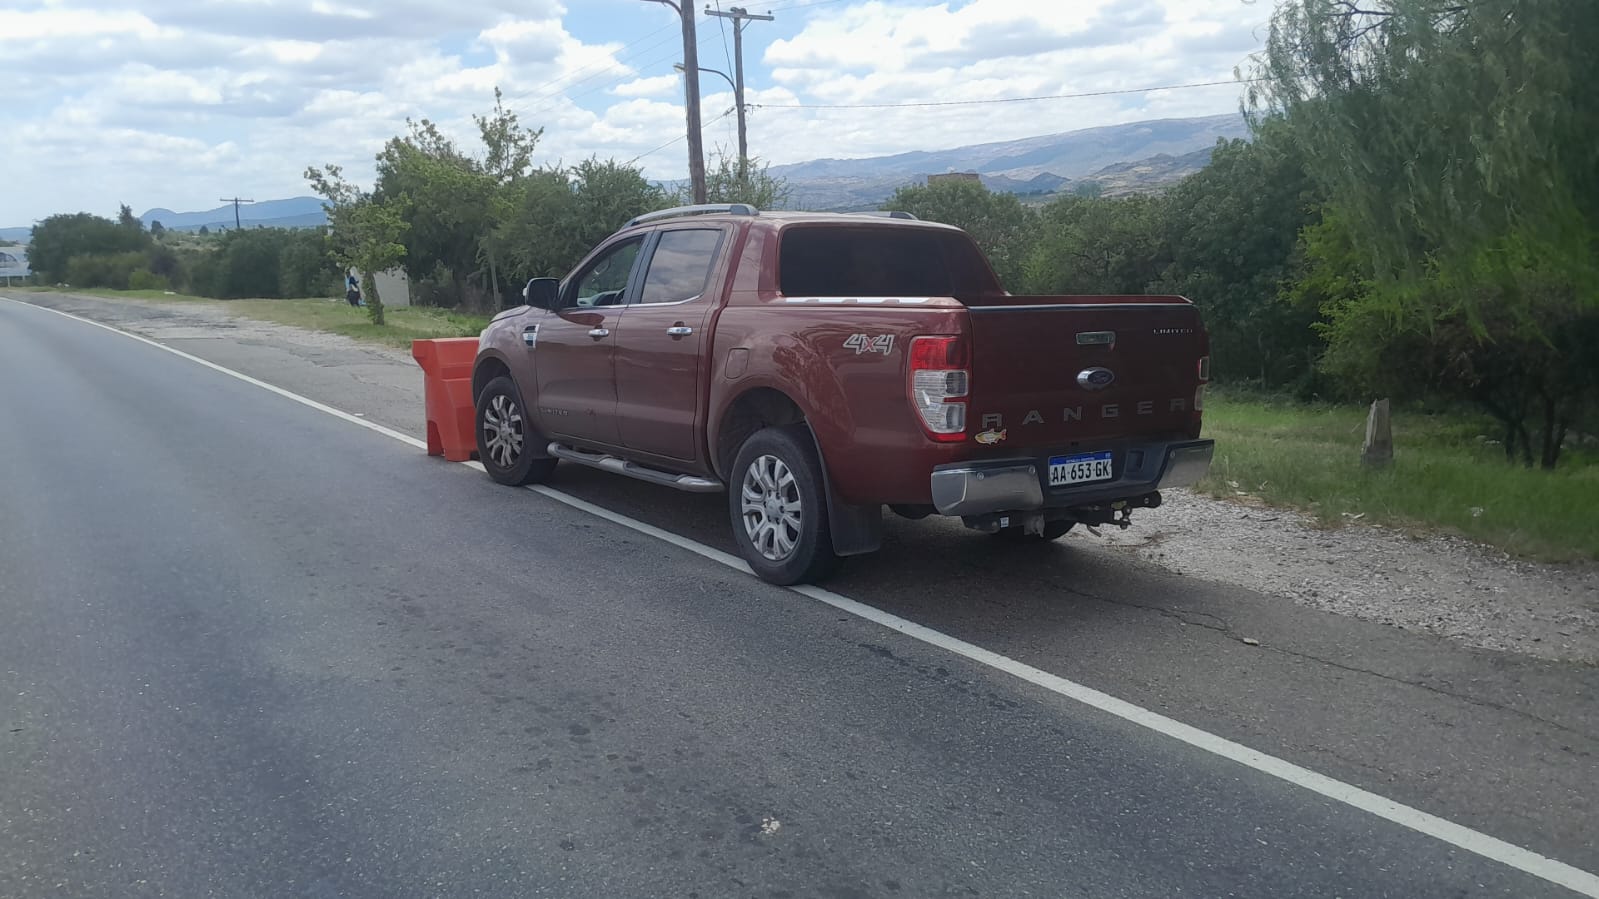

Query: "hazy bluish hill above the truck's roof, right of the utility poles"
<box><xmin>771</xmin><ymin>114</ymin><xmax>1249</xmax><ymax>210</ymax></box>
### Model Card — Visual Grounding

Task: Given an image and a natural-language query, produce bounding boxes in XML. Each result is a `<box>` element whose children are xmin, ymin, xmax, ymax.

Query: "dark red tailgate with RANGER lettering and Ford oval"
<box><xmin>967</xmin><ymin>296</ymin><xmax>1209</xmax><ymax>451</ymax></box>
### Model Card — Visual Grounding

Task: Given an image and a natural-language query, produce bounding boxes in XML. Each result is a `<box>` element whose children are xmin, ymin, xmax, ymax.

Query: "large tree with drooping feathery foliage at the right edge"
<box><xmin>1252</xmin><ymin>0</ymin><xmax>1599</xmax><ymax>467</ymax></box>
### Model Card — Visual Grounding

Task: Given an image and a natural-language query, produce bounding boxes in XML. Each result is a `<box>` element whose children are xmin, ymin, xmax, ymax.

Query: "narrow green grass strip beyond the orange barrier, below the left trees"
<box><xmin>12</xmin><ymin>288</ymin><xmax>489</xmax><ymax>349</ymax></box>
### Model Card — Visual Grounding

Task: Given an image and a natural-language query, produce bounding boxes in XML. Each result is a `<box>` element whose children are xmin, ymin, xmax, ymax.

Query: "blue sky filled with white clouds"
<box><xmin>0</xmin><ymin>0</ymin><xmax>1271</xmax><ymax>226</ymax></box>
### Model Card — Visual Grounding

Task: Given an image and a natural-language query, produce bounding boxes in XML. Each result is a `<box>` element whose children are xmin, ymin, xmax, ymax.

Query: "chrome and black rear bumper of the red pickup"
<box><xmin>932</xmin><ymin>440</ymin><xmax>1215</xmax><ymax>517</ymax></box>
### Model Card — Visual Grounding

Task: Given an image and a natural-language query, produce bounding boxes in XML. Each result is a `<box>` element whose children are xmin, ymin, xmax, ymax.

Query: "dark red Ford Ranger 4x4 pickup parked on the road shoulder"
<box><xmin>472</xmin><ymin>205</ymin><xmax>1212</xmax><ymax>584</ymax></box>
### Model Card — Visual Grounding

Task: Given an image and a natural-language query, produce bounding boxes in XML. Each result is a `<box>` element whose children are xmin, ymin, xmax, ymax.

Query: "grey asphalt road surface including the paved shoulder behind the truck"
<box><xmin>0</xmin><ymin>301</ymin><xmax>1599</xmax><ymax>897</ymax></box>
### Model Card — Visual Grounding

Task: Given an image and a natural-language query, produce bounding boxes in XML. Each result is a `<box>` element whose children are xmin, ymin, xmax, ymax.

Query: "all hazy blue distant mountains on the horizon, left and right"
<box><xmin>0</xmin><ymin>114</ymin><xmax>1249</xmax><ymax>240</ymax></box>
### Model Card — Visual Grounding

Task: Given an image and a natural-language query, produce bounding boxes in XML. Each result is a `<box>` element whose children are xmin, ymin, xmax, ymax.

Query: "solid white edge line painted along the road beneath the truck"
<box><xmin>6</xmin><ymin>298</ymin><xmax>1599</xmax><ymax>899</ymax></box>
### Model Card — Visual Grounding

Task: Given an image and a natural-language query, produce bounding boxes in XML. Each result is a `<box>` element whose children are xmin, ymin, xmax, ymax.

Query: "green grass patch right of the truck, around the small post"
<box><xmin>1198</xmin><ymin>392</ymin><xmax>1599</xmax><ymax>561</ymax></box>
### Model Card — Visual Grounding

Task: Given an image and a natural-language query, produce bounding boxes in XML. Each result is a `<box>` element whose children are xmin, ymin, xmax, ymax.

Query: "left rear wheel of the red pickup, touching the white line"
<box><xmin>728</xmin><ymin>426</ymin><xmax>838</xmax><ymax>587</ymax></box>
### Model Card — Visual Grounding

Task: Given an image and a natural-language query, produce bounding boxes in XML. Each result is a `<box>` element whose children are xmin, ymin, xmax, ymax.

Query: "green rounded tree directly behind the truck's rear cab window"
<box><xmin>887</xmin><ymin>181</ymin><xmax>1038</xmax><ymax>290</ymax></box>
